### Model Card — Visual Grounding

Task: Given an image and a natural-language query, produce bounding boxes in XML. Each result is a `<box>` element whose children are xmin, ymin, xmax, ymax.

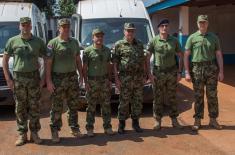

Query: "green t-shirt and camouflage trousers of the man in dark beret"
<box><xmin>147</xmin><ymin>35</ymin><xmax>181</xmax><ymax>119</ymax></box>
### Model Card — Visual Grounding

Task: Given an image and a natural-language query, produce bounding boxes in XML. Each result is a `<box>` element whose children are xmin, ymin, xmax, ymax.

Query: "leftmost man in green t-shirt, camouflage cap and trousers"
<box><xmin>3</xmin><ymin>17</ymin><xmax>46</xmax><ymax>146</ymax></box>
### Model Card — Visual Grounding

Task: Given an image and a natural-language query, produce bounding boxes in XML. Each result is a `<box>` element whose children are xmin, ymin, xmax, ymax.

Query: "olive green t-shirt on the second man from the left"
<box><xmin>47</xmin><ymin>37</ymin><xmax>80</xmax><ymax>73</ymax></box>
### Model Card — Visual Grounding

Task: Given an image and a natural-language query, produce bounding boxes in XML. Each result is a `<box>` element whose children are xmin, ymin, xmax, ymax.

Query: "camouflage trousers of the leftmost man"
<box><xmin>13</xmin><ymin>71</ymin><xmax>41</xmax><ymax>135</ymax></box>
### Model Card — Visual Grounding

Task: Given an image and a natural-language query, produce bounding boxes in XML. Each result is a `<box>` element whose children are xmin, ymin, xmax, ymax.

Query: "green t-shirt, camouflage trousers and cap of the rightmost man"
<box><xmin>185</xmin><ymin>16</ymin><xmax>220</xmax><ymax>119</ymax></box>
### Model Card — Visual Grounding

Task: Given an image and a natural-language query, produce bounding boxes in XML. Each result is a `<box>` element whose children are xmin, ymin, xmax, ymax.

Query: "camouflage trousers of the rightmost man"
<box><xmin>191</xmin><ymin>63</ymin><xmax>219</xmax><ymax>119</ymax></box>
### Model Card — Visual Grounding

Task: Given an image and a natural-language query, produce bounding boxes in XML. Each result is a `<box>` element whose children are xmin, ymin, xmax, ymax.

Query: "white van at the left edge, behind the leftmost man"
<box><xmin>0</xmin><ymin>2</ymin><xmax>46</xmax><ymax>105</ymax></box>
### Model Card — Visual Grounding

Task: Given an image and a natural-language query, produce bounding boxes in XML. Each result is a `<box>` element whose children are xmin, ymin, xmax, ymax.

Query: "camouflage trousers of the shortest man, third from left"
<box><xmin>86</xmin><ymin>79</ymin><xmax>112</xmax><ymax>130</ymax></box>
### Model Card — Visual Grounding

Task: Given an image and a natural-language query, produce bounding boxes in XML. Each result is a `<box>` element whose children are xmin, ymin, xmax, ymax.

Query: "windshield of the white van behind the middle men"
<box><xmin>80</xmin><ymin>18</ymin><xmax>152</xmax><ymax>48</ymax></box>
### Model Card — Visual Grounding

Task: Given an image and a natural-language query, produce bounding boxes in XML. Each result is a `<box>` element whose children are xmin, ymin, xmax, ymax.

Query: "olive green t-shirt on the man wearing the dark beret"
<box><xmin>147</xmin><ymin>35</ymin><xmax>182</xmax><ymax>68</ymax></box>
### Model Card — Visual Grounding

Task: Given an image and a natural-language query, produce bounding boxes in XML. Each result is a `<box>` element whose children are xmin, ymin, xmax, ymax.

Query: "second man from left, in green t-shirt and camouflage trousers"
<box><xmin>46</xmin><ymin>18</ymin><xmax>83</xmax><ymax>143</ymax></box>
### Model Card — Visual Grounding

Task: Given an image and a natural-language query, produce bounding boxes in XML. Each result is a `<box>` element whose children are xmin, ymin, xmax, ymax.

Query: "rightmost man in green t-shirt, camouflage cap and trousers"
<box><xmin>184</xmin><ymin>15</ymin><xmax>224</xmax><ymax>130</ymax></box>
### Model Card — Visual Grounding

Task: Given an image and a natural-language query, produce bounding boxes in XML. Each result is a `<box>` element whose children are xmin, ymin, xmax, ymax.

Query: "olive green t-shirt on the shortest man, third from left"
<box><xmin>83</xmin><ymin>45</ymin><xmax>111</xmax><ymax>76</ymax></box>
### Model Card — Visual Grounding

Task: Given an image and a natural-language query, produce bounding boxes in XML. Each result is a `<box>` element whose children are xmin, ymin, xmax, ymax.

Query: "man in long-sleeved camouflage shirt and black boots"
<box><xmin>113</xmin><ymin>23</ymin><xmax>146</xmax><ymax>134</ymax></box>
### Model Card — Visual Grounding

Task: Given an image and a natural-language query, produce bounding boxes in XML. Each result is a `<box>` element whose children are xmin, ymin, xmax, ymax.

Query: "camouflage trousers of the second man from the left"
<box><xmin>50</xmin><ymin>72</ymin><xmax>79</xmax><ymax>131</ymax></box>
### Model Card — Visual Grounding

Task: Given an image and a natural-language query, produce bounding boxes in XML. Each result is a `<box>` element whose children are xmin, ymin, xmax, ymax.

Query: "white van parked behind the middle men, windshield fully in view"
<box><xmin>72</xmin><ymin>0</ymin><xmax>154</xmax><ymax>102</ymax></box>
